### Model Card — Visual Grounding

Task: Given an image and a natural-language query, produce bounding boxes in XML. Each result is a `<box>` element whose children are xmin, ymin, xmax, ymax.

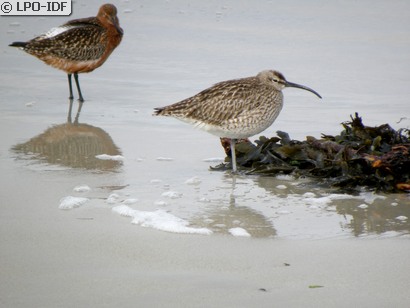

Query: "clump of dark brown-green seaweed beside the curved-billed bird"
<box><xmin>214</xmin><ymin>113</ymin><xmax>410</xmax><ymax>192</ymax></box>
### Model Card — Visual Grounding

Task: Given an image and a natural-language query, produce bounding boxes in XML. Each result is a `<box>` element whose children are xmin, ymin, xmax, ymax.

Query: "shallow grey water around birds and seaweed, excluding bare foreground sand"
<box><xmin>0</xmin><ymin>1</ymin><xmax>410</xmax><ymax>239</ymax></box>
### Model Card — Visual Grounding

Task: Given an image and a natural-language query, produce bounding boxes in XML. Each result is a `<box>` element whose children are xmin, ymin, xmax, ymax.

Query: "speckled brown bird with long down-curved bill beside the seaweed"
<box><xmin>154</xmin><ymin>70</ymin><xmax>322</xmax><ymax>172</ymax></box>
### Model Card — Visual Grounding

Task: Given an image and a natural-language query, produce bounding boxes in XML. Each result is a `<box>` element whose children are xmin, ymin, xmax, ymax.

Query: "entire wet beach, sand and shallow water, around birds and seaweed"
<box><xmin>0</xmin><ymin>0</ymin><xmax>410</xmax><ymax>307</ymax></box>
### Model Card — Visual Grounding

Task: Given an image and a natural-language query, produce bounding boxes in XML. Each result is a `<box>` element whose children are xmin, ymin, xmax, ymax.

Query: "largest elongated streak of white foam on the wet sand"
<box><xmin>112</xmin><ymin>205</ymin><xmax>212</xmax><ymax>235</ymax></box>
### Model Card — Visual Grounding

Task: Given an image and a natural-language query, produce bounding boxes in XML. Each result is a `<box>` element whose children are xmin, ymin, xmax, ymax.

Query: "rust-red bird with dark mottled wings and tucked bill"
<box><xmin>9</xmin><ymin>4</ymin><xmax>123</xmax><ymax>102</ymax></box>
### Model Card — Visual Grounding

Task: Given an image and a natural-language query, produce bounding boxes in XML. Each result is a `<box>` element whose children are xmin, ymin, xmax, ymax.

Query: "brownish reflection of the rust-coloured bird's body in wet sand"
<box><xmin>12</xmin><ymin>123</ymin><xmax>122</xmax><ymax>171</ymax></box>
